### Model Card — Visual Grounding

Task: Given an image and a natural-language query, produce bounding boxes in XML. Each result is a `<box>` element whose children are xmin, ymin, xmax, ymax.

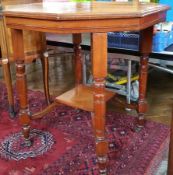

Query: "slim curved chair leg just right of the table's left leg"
<box><xmin>41</xmin><ymin>52</ymin><xmax>51</xmax><ymax>105</ymax></box>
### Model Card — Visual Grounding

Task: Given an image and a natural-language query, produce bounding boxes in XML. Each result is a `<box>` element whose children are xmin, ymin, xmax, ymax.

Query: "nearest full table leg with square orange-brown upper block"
<box><xmin>91</xmin><ymin>33</ymin><xmax>108</xmax><ymax>174</ymax></box>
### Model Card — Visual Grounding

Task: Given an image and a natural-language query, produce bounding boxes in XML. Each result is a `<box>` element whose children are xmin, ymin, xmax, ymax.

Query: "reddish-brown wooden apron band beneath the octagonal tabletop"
<box><xmin>6</xmin><ymin>12</ymin><xmax>166</xmax><ymax>34</ymax></box>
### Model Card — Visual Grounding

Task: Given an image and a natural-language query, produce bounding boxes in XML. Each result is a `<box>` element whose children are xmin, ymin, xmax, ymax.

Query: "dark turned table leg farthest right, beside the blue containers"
<box><xmin>136</xmin><ymin>27</ymin><xmax>153</xmax><ymax>130</ymax></box>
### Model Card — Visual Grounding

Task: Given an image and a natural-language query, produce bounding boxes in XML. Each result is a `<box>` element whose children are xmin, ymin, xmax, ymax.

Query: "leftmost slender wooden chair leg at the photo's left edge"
<box><xmin>2</xmin><ymin>58</ymin><xmax>16</xmax><ymax>118</ymax></box>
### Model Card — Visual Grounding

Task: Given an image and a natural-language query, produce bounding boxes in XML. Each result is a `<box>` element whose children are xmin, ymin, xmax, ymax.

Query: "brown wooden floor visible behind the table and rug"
<box><xmin>0</xmin><ymin>45</ymin><xmax>173</xmax><ymax>124</ymax></box>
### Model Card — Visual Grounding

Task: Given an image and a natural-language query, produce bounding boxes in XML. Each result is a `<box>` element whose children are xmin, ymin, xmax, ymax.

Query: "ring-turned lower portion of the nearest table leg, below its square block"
<box><xmin>92</xmin><ymin>78</ymin><xmax>108</xmax><ymax>175</ymax></box>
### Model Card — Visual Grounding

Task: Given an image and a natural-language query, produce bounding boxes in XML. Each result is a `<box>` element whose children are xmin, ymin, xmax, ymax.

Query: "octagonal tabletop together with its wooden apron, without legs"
<box><xmin>4</xmin><ymin>2</ymin><xmax>169</xmax><ymax>34</ymax></box>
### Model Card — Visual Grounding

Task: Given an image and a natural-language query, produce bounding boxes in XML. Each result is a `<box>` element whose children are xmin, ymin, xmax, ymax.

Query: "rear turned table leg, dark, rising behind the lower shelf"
<box><xmin>73</xmin><ymin>34</ymin><xmax>82</xmax><ymax>85</ymax></box>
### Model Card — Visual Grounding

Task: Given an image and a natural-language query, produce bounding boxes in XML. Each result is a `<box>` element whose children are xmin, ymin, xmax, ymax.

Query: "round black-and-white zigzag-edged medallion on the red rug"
<box><xmin>0</xmin><ymin>129</ymin><xmax>54</xmax><ymax>161</ymax></box>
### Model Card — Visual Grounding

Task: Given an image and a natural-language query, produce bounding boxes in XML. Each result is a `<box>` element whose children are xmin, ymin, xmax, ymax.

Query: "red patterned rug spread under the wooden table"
<box><xmin>0</xmin><ymin>84</ymin><xmax>169</xmax><ymax>175</ymax></box>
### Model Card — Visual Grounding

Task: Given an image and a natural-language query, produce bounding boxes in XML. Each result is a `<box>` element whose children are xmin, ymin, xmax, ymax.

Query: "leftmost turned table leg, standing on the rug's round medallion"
<box><xmin>11</xmin><ymin>29</ymin><xmax>31</xmax><ymax>146</ymax></box>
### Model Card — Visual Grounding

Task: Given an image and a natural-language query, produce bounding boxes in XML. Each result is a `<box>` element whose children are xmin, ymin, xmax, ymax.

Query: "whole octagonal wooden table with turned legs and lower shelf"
<box><xmin>4</xmin><ymin>2</ymin><xmax>169</xmax><ymax>174</ymax></box>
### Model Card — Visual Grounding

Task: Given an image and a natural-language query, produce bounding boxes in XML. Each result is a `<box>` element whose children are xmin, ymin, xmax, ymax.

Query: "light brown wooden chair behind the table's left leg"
<box><xmin>0</xmin><ymin>0</ymin><xmax>50</xmax><ymax>118</ymax></box>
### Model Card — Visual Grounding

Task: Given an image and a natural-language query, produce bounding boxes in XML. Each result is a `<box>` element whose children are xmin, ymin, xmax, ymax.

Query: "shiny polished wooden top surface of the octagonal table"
<box><xmin>4</xmin><ymin>1</ymin><xmax>169</xmax><ymax>20</ymax></box>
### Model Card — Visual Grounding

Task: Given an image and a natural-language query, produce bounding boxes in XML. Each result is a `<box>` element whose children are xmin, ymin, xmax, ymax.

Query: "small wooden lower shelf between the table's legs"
<box><xmin>55</xmin><ymin>85</ymin><xmax>115</xmax><ymax>112</ymax></box>
